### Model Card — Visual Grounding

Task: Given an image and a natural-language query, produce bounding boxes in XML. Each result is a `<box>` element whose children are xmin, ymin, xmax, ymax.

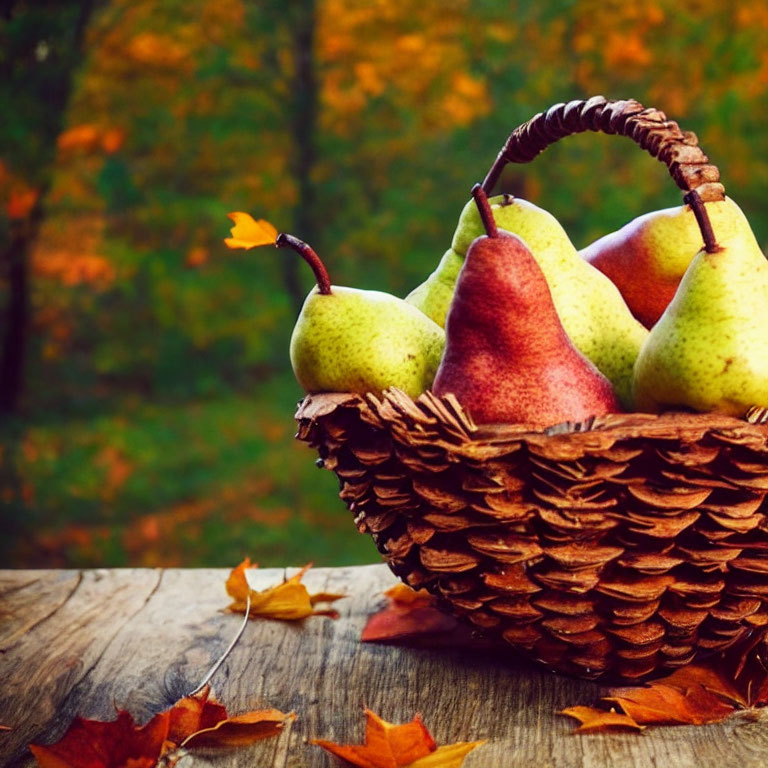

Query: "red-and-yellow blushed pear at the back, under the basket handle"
<box><xmin>579</xmin><ymin>198</ymin><xmax>749</xmax><ymax>328</ymax></box>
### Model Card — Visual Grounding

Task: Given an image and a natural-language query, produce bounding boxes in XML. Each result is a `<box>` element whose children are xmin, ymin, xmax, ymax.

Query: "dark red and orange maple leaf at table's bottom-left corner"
<box><xmin>29</xmin><ymin>686</ymin><xmax>294</xmax><ymax>768</ymax></box>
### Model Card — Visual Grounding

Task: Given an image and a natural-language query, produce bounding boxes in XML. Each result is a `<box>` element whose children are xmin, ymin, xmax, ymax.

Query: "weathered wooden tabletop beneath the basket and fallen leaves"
<box><xmin>0</xmin><ymin>565</ymin><xmax>768</xmax><ymax>768</ymax></box>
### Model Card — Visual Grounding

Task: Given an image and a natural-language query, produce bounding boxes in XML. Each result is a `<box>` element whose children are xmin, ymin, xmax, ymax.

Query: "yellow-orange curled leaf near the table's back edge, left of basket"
<box><xmin>226</xmin><ymin>558</ymin><xmax>346</xmax><ymax>621</ymax></box>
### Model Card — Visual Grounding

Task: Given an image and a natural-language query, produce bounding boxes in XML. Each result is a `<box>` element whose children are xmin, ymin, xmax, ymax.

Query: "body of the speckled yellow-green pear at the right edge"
<box><xmin>634</xmin><ymin>230</ymin><xmax>768</xmax><ymax>417</ymax></box>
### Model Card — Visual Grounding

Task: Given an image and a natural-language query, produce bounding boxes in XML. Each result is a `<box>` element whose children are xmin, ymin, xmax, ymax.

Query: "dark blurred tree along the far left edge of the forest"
<box><xmin>0</xmin><ymin>0</ymin><xmax>94</xmax><ymax>414</ymax></box>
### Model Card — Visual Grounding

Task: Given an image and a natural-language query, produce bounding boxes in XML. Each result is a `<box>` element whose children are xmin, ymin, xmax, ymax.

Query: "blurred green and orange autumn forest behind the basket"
<box><xmin>0</xmin><ymin>0</ymin><xmax>768</xmax><ymax>567</ymax></box>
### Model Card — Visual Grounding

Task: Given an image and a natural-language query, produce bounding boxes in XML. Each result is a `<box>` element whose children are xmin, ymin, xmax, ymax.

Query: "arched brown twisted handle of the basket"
<box><xmin>482</xmin><ymin>96</ymin><xmax>725</xmax><ymax>202</ymax></box>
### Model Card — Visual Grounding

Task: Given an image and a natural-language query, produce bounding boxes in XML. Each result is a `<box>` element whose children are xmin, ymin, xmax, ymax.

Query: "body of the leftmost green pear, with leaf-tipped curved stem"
<box><xmin>290</xmin><ymin>286</ymin><xmax>445</xmax><ymax>398</ymax></box>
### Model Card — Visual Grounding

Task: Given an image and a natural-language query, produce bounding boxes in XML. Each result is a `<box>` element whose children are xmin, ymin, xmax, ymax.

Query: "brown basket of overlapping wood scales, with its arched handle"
<box><xmin>296</xmin><ymin>97</ymin><xmax>768</xmax><ymax>681</ymax></box>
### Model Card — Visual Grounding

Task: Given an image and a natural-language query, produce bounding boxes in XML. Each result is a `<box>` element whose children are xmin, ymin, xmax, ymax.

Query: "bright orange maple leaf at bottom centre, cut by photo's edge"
<box><xmin>311</xmin><ymin>708</ymin><xmax>484</xmax><ymax>768</ymax></box>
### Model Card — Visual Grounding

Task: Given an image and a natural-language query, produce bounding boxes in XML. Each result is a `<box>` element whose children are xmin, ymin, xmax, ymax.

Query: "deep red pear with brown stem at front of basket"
<box><xmin>433</xmin><ymin>185</ymin><xmax>620</xmax><ymax>428</ymax></box>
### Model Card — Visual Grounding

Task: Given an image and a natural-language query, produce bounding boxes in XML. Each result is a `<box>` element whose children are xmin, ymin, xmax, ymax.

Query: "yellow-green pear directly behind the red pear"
<box><xmin>406</xmin><ymin>195</ymin><xmax>648</xmax><ymax>409</ymax></box>
